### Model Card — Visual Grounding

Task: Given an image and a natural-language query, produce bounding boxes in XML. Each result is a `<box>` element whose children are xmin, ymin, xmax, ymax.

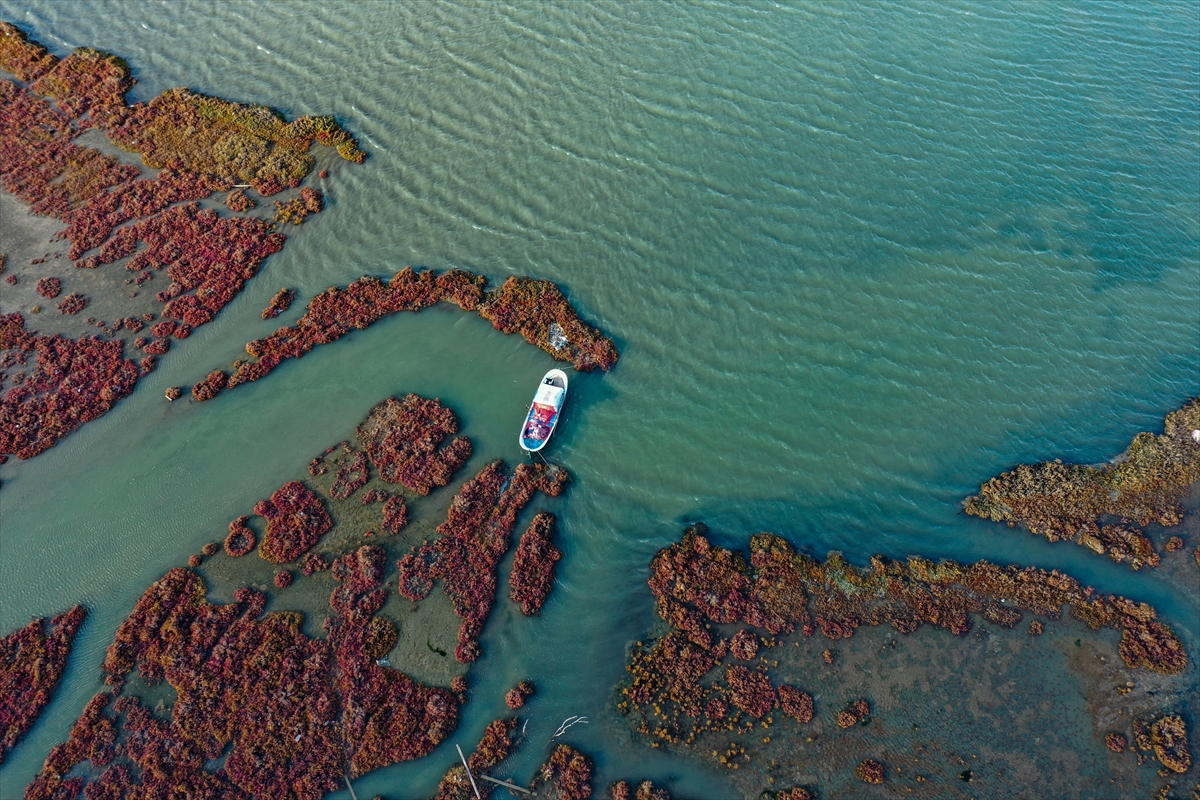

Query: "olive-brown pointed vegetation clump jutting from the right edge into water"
<box><xmin>964</xmin><ymin>398</ymin><xmax>1200</xmax><ymax>569</ymax></box>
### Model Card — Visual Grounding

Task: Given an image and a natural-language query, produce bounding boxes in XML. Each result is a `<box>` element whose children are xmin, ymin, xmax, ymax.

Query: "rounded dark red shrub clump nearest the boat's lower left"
<box><xmin>355</xmin><ymin>395</ymin><xmax>470</xmax><ymax>494</ymax></box>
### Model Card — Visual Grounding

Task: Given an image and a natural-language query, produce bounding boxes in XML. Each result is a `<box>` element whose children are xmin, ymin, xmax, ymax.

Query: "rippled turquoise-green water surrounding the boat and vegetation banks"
<box><xmin>0</xmin><ymin>0</ymin><xmax>1200</xmax><ymax>796</ymax></box>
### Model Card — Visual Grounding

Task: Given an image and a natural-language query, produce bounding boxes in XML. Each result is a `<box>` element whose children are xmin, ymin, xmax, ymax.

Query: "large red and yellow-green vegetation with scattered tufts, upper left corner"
<box><xmin>0</xmin><ymin>23</ymin><xmax>364</xmax><ymax>462</ymax></box>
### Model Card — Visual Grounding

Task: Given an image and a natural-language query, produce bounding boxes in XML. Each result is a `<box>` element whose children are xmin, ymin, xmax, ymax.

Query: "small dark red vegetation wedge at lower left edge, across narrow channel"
<box><xmin>0</xmin><ymin>606</ymin><xmax>88</xmax><ymax>764</ymax></box>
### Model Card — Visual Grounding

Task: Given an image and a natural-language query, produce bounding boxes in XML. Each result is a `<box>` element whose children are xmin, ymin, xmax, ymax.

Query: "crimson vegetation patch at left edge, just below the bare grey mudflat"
<box><xmin>0</xmin><ymin>313</ymin><xmax>139</xmax><ymax>458</ymax></box>
